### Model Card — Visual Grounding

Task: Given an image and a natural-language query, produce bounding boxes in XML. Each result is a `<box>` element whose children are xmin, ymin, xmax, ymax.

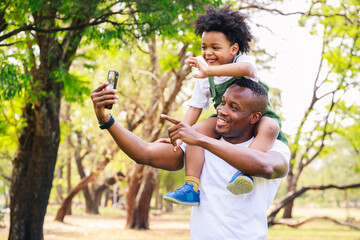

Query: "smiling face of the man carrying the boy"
<box><xmin>215</xmin><ymin>84</ymin><xmax>261</xmax><ymax>144</ymax></box>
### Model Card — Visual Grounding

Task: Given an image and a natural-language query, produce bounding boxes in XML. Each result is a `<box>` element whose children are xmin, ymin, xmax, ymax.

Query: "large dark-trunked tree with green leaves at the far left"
<box><xmin>0</xmin><ymin>0</ymin><xmax>217</xmax><ymax>239</ymax></box>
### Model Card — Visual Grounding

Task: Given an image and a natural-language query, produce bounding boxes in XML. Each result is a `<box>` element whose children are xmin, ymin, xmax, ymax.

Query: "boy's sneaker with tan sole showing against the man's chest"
<box><xmin>226</xmin><ymin>171</ymin><xmax>254</xmax><ymax>195</ymax></box>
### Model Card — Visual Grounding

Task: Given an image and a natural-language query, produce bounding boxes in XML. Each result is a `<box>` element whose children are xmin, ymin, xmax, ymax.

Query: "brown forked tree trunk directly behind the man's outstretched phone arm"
<box><xmin>121</xmin><ymin>37</ymin><xmax>198</xmax><ymax>229</ymax></box>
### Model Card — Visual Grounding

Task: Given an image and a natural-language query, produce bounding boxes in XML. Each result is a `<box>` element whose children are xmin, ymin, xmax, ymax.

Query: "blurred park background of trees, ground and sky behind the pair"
<box><xmin>0</xmin><ymin>0</ymin><xmax>360</xmax><ymax>239</ymax></box>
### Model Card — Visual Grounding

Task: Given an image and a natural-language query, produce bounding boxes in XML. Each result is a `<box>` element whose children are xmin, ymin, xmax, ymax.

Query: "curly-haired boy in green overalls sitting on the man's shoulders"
<box><xmin>164</xmin><ymin>6</ymin><xmax>287</xmax><ymax>206</ymax></box>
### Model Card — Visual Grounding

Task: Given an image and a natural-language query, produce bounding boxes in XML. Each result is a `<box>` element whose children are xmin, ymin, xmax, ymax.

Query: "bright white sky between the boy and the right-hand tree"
<box><xmin>250</xmin><ymin>1</ymin><xmax>322</xmax><ymax>134</ymax></box>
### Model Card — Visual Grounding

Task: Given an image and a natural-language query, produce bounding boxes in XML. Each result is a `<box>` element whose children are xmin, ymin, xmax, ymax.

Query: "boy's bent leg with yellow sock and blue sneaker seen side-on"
<box><xmin>164</xmin><ymin>117</ymin><xmax>219</xmax><ymax>206</ymax></box>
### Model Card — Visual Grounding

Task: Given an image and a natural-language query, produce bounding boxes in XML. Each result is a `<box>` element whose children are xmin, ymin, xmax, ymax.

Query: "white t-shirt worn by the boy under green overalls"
<box><xmin>185</xmin><ymin>55</ymin><xmax>258</xmax><ymax>109</ymax></box>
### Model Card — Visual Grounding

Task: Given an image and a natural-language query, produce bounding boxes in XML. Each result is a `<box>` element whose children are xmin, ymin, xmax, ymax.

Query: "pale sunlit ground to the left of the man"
<box><xmin>0</xmin><ymin>210</ymin><xmax>190</xmax><ymax>240</ymax></box>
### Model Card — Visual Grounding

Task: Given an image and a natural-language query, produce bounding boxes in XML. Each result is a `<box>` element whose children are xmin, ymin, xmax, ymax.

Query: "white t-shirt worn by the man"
<box><xmin>182</xmin><ymin>138</ymin><xmax>290</xmax><ymax>240</ymax></box>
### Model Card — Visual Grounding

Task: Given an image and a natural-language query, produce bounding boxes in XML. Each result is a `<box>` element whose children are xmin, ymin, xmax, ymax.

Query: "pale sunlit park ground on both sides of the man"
<box><xmin>0</xmin><ymin>205</ymin><xmax>360</xmax><ymax>240</ymax></box>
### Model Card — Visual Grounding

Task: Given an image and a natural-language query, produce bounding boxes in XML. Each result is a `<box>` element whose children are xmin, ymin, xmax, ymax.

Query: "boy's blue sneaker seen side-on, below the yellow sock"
<box><xmin>164</xmin><ymin>182</ymin><xmax>200</xmax><ymax>206</ymax></box>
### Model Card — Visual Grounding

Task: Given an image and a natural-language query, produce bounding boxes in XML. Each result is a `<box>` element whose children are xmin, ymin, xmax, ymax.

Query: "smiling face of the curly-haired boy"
<box><xmin>201</xmin><ymin>31</ymin><xmax>239</xmax><ymax>66</ymax></box>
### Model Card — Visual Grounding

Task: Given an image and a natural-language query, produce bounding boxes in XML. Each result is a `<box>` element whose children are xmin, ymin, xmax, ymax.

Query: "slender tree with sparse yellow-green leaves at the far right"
<box><xmin>236</xmin><ymin>0</ymin><xmax>360</xmax><ymax>224</ymax></box>
